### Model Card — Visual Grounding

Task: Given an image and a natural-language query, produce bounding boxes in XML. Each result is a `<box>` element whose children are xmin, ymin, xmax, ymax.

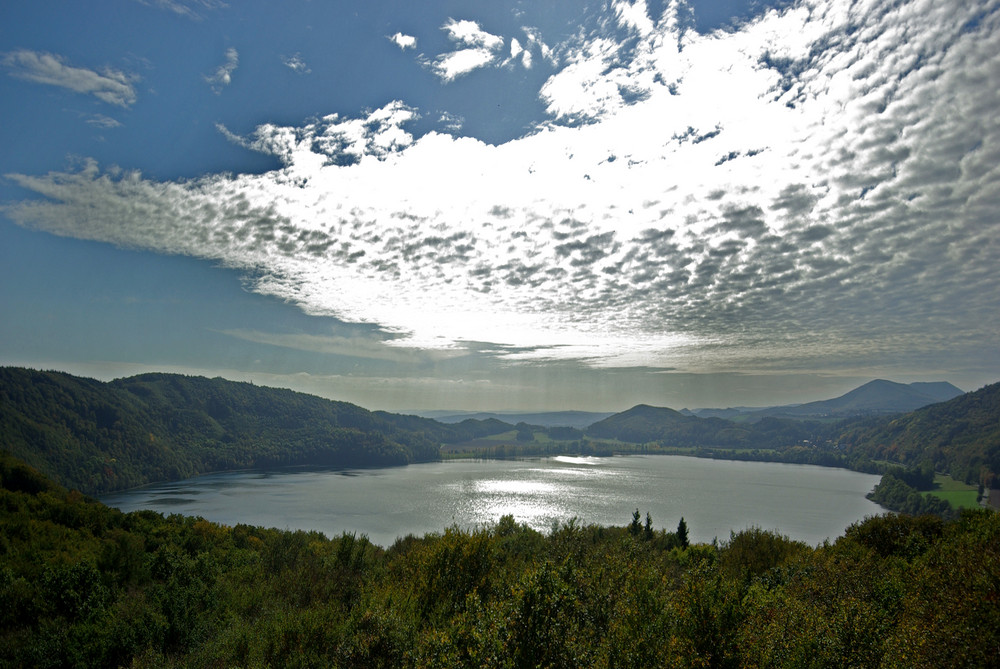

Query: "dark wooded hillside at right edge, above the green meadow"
<box><xmin>838</xmin><ymin>383</ymin><xmax>1000</xmax><ymax>487</ymax></box>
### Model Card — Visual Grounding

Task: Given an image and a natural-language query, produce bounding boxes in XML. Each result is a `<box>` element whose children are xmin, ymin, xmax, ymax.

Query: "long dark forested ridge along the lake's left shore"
<box><xmin>0</xmin><ymin>367</ymin><xmax>511</xmax><ymax>494</ymax></box>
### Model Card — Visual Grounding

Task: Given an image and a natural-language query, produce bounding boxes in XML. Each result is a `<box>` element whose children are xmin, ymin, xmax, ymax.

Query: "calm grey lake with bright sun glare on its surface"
<box><xmin>102</xmin><ymin>455</ymin><xmax>883</xmax><ymax>546</ymax></box>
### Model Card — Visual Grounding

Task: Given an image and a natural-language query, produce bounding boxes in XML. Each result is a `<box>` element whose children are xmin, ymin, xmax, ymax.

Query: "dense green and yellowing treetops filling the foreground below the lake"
<box><xmin>0</xmin><ymin>456</ymin><xmax>1000</xmax><ymax>667</ymax></box>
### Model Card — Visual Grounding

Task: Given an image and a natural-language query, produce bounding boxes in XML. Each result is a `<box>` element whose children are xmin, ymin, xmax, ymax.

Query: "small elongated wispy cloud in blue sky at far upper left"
<box><xmin>0</xmin><ymin>49</ymin><xmax>136</xmax><ymax>107</ymax></box>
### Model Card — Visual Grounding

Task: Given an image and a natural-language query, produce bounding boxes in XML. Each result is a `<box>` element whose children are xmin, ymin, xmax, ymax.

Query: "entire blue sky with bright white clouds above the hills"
<box><xmin>0</xmin><ymin>0</ymin><xmax>1000</xmax><ymax>411</ymax></box>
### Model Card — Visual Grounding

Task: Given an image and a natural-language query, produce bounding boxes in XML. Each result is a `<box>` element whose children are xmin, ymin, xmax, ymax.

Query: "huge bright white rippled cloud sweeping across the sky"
<box><xmin>6</xmin><ymin>0</ymin><xmax>1000</xmax><ymax>374</ymax></box>
